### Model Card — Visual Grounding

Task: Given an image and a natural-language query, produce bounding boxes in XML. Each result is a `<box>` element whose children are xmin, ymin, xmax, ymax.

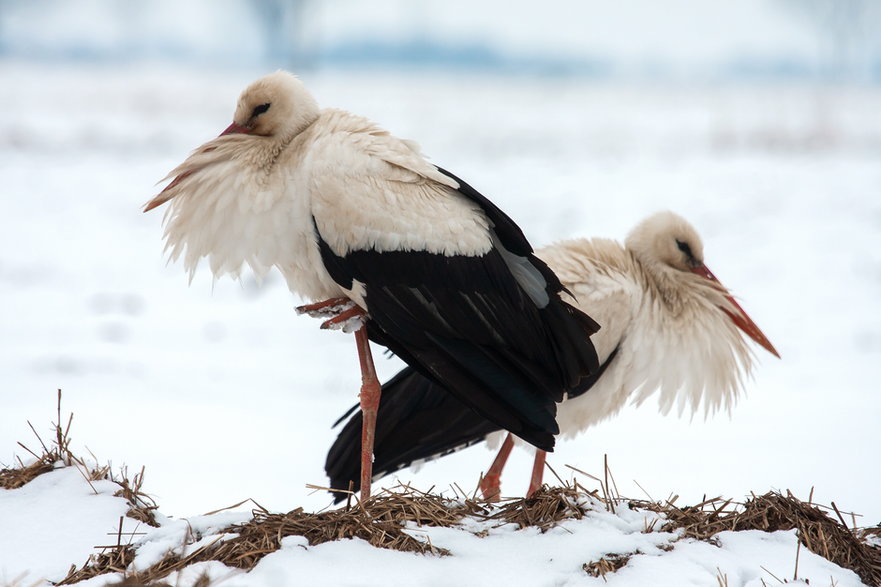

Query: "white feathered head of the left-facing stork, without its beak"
<box><xmin>222</xmin><ymin>70</ymin><xmax>318</xmax><ymax>138</ymax></box>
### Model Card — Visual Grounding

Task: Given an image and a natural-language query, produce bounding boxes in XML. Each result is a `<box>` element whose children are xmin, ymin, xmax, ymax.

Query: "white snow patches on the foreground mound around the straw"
<box><xmin>0</xmin><ymin>467</ymin><xmax>863</xmax><ymax>587</ymax></box>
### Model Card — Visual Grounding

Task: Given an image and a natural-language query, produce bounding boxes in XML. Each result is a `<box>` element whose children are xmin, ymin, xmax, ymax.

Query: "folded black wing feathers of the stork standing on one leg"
<box><xmin>326</xmin><ymin>243</ymin><xmax>560</xmax><ymax>450</ymax></box>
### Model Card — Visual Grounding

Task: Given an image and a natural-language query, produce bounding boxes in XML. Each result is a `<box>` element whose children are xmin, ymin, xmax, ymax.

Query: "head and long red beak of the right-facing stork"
<box><xmin>626</xmin><ymin>212</ymin><xmax>780</xmax><ymax>358</ymax></box>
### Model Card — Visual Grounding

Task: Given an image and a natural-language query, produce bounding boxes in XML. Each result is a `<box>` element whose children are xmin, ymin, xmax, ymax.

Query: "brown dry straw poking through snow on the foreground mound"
<box><xmin>0</xmin><ymin>404</ymin><xmax>881</xmax><ymax>587</ymax></box>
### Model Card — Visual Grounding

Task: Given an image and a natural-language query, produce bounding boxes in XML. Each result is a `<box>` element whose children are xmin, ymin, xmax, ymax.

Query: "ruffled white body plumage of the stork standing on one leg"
<box><xmin>156</xmin><ymin>109</ymin><xmax>493</xmax><ymax>300</ymax></box>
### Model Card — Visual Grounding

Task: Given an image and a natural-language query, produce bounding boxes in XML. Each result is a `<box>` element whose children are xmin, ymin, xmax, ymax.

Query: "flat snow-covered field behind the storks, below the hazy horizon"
<box><xmin>0</xmin><ymin>63</ymin><xmax>881</xmax><ymax>584</ymax></box>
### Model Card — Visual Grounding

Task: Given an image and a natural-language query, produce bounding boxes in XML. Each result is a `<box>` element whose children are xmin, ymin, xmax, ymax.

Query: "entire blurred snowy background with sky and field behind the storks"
<box><xmin>0</xmin><ymin>0</ymin><xmax>881</xmax><ymax>530</ymax></box>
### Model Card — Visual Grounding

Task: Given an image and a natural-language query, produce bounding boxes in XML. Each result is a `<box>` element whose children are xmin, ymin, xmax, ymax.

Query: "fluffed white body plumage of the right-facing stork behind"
<box><xmin>489</xmin><ymin>217</ymin><xmax>753</xmax><ymax>448</ymax></box>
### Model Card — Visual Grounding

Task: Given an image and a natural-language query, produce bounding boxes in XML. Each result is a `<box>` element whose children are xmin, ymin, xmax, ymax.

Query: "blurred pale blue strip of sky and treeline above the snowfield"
<box><xmin>0</xmin><ymin>0</ymin><xmax>881</xmax><ymax>82</ymax></box>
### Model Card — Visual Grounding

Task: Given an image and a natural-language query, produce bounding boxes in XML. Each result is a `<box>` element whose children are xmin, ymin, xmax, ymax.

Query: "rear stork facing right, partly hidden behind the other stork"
<box><xmin>326</xmin><ymin>212</ymin><xmax>780</xmax><ymax>499</ymax></box>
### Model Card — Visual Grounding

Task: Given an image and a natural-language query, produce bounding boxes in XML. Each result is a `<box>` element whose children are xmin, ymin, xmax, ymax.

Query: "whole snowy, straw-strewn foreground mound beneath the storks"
<box><xmin>0</xmin><ymin>458</ymin><xmax>881</xmax><ymax>587</ymax></box>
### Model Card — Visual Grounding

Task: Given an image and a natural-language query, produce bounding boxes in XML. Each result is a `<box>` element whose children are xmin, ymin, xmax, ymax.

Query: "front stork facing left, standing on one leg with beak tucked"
<box><xmin>144</xmin><ymin>71</ymin><xmax>598</xmax><ymax>498</ymax></box>
